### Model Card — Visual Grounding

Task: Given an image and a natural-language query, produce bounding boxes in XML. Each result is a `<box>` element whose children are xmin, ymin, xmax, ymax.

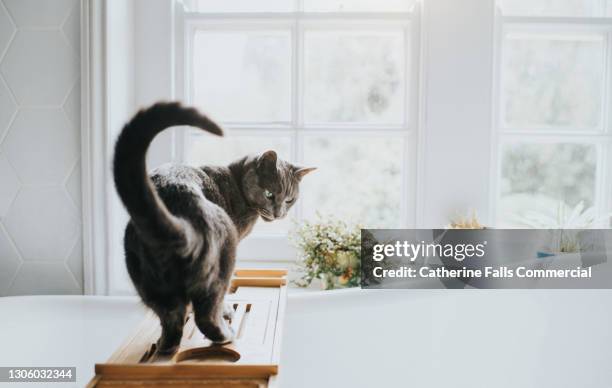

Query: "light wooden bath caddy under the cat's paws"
<box><xmin>88</xmin><ymin>269</ymin><xmax>287</xmax><ymax>388</ymax></box>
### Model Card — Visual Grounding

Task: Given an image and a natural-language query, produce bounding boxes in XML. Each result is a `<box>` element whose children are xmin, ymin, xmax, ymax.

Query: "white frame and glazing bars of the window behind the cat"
<box><xmin>175</xmin><ymin>4</ymin><xmax>420</xmax><ymax>263</ymax></box>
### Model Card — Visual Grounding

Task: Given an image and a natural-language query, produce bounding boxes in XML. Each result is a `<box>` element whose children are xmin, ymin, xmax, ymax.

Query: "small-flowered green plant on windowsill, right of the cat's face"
<box><xmin>293</xmin><ymin>217</ymin><xmax>361</xmax><ymax>290</ymax></box>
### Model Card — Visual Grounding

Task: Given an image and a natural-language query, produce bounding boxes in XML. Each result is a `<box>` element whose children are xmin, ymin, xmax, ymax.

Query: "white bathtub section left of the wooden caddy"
<box><xmin>0</xmin><ymin>296</ymin><xmax>145</xmax><ymax>388</ymax></box>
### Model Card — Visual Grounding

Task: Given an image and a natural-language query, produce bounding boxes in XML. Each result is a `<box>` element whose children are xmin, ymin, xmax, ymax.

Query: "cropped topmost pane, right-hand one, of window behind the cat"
<box><xmin>304</xmin><ymin>0</ymin><xmax>416</xmax><ymax>12</ymax></box>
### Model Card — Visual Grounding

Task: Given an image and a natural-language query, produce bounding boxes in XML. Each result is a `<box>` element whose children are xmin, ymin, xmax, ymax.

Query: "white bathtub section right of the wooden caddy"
<box><xmin>280</xmin><ymin>289</ymin><xmax>612</xmax><ymax>388</ymax></box>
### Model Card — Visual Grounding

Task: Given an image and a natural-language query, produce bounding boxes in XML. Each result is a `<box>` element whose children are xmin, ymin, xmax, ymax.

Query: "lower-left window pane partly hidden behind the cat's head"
<box><xmin>185</xmin><ymin>132</ymin><xmax>294</xmax><ymax>235</ymax></box>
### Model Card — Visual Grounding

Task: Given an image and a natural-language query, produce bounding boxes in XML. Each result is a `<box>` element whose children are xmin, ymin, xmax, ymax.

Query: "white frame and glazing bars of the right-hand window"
<box><xmin>490</xmin><ymin>5</ymin><xmax>612</xmax><ymax>223</ymax></box>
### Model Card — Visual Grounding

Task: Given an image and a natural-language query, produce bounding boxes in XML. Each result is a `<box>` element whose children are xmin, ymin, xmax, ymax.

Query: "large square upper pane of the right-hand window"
<box><xmin>502</xmin><ymin>33</ymin><xmax>604</xmax><ymax>128</ymax></box>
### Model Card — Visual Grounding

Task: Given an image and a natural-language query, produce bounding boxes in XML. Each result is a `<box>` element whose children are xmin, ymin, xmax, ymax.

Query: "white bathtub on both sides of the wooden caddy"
<box><xmin>0</xmin><ymin>289</ymin><xmax>612</xmax><ymax>388</ymax></box>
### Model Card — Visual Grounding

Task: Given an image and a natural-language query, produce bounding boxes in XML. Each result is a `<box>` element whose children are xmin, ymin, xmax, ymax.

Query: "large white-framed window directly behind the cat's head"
<box><xmin>179</xmin><ymin>0</ymin><xmax>418</xmax><ymax>259</ymax></box>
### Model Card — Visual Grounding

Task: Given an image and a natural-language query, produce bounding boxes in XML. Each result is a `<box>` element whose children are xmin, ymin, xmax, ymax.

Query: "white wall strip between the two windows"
<box><xmin>417</xmin><ymin>0</ymin><xmax>494</xmax><ymax>228</ymax></box>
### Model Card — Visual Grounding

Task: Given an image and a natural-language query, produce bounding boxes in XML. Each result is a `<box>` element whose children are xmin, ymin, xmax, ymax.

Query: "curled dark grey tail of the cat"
<box><xmin>113</xmin><ymin>102</ymin><xmax>223</xmax><ymax>249</ymax></box>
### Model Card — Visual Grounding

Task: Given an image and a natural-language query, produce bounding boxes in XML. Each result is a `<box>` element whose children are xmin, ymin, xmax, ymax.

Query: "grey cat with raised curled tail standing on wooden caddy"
<box><xmin>113</xmin><ymin>103</ymin><xmax>314</xmax><ymax>354</ymax></box>
